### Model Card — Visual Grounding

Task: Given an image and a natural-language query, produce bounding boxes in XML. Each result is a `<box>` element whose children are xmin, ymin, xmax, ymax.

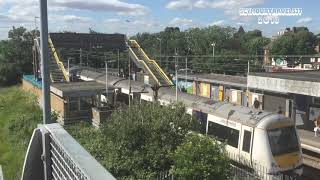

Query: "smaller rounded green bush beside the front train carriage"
<box><xmin>171</xmin><ymin>134</ymin><xmax>230</xmax><ymax>180</ymax></box>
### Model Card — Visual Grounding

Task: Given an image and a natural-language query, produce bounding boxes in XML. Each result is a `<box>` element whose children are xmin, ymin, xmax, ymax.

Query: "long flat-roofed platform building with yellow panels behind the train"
<box><xmin>178</xmin><ymin>71</ymin><xmax>320</xmax><ymax>130</ymax></box>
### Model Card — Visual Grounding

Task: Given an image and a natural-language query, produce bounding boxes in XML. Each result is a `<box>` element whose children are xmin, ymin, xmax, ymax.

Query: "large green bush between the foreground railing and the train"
<box><xmin>67</xmin><ymin>104</ymin><xmax>198</xmax><ymax>179</ymax></box>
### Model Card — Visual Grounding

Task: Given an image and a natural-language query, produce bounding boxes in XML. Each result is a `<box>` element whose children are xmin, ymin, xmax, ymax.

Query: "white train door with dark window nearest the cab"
<box><xmin>239</xmin><ymin>125</ymin><xmax>253</xmax><ymax>167</ymax></box>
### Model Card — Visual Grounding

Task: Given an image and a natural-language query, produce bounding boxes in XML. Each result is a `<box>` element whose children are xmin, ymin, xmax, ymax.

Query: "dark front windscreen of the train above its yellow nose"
<box><xmin>268</xmin><ymin>126</ymin><xmax>299</xmax><ymax>156</ymax></box>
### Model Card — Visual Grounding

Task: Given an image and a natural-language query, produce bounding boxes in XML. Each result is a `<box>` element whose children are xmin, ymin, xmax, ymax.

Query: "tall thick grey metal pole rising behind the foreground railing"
<box><xmin>40</xmin><ymin>0</ymin><xmax>51</xmax><ymax>124</ymax></box>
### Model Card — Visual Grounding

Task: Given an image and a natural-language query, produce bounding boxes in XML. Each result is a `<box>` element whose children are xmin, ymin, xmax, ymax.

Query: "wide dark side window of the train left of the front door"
<box><xmin>208</xmin><ymin>121</ymin><xmax>239</xmax><ymax>148</ymax></box>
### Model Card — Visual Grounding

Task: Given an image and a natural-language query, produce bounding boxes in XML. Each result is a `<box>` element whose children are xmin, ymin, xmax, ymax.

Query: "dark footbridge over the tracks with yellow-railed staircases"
<box><xmin>33</xmin><ymin>33</ymin><xmax>174</xmax><ymax>86</ymax></box>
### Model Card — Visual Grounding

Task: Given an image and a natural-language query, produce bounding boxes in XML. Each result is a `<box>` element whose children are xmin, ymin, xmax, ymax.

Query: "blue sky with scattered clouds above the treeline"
<box><xmin>0</xmin><ymin>0</ymin><xmax>320</xmax><ymax>39</ymax></box>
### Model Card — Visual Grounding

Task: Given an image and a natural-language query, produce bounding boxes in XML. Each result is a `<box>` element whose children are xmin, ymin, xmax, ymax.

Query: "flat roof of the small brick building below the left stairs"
<box><xmin>50</xmin><ymin>81</ymin><xmax>106</xmax><ymax>97</ymax></box>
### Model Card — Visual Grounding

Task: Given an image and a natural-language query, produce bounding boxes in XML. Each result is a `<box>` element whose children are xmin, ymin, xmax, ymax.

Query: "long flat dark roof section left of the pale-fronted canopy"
<box><xmin>178</xmin><ymin>73</ymin><xmax>247</xmax><ymax>87</ymax></box>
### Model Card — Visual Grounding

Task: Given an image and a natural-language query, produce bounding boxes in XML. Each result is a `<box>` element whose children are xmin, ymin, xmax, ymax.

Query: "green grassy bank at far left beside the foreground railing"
<box><xmin>0</xmin><ymin>86</ymin><xmax>41</xmax><ymax>180</ymax></box>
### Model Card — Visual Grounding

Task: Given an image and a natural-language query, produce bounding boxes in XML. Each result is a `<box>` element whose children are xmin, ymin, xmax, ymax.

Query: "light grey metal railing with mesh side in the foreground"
<box><xmin>21</xmin><ymin>124</ymin><xmax>115</xmax><ymax>180</ymax></box>
